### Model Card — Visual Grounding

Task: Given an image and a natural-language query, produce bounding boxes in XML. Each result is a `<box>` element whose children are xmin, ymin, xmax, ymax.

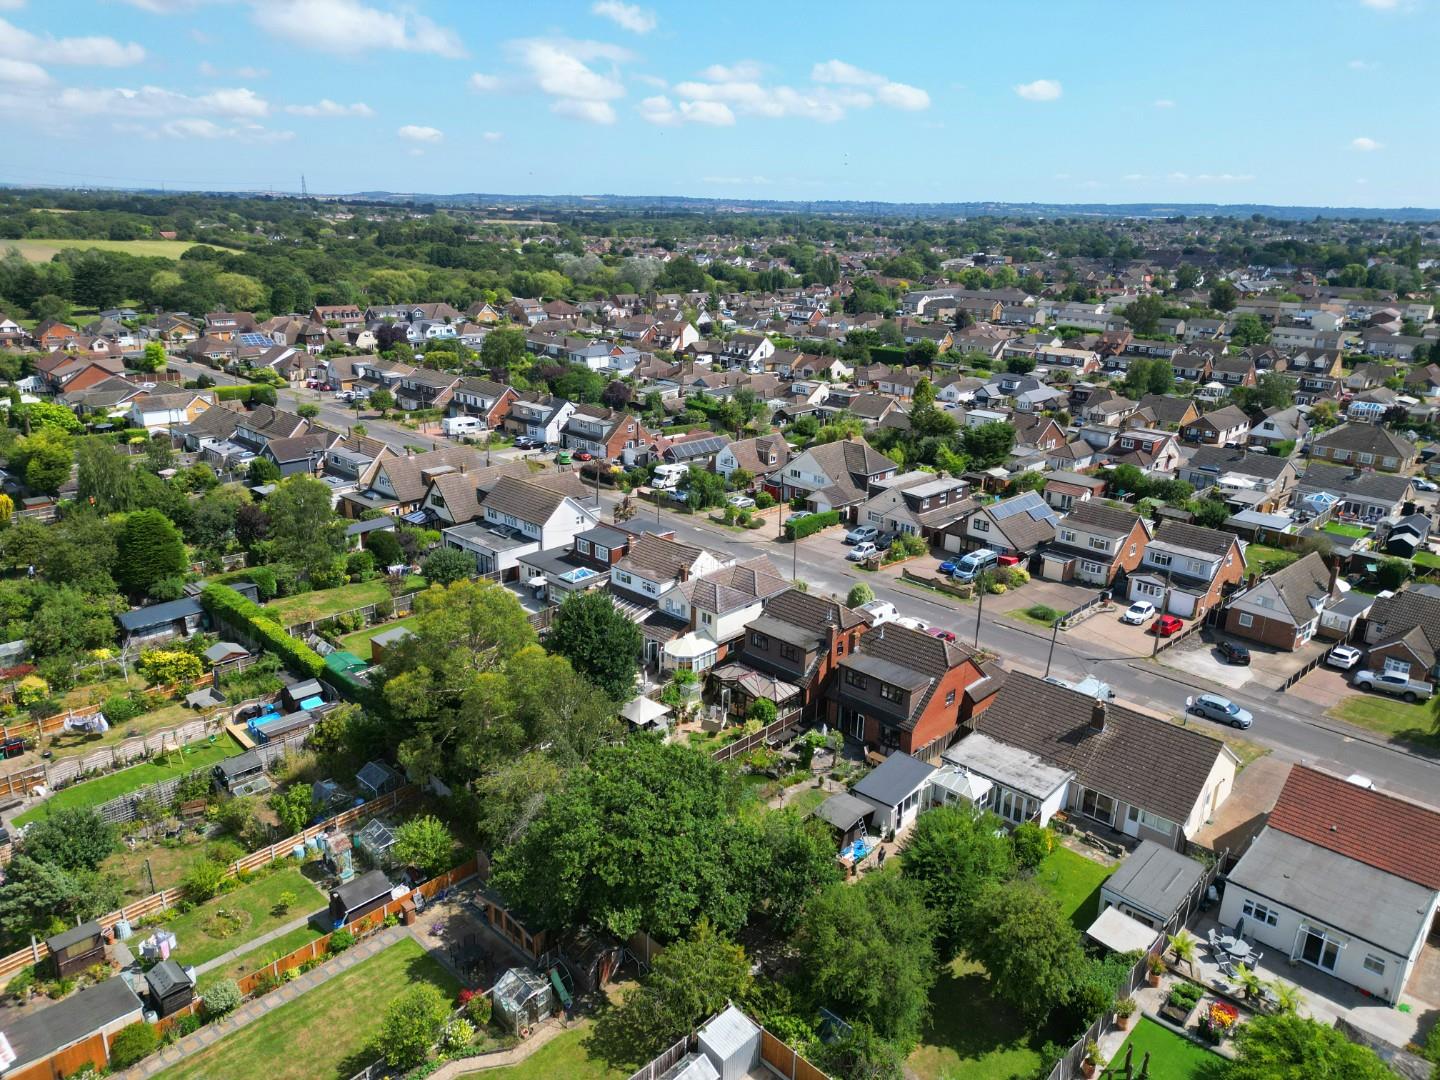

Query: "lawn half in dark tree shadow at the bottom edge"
<box><xmin>906</xmin><ymin>956</ymin><xmax>1050</xmax><ymax>1080</ymax></box>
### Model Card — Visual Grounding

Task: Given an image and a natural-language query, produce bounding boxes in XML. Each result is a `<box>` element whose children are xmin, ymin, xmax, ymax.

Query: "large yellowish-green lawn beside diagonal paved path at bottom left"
<box><xmin>158</xmin><ymin>937</ymin><xmax>457</xmax><ymax>1080</ymax></box>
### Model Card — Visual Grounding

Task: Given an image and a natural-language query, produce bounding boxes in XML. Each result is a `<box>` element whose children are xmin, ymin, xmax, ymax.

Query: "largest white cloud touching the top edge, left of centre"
<box><xmin>253</xmin><ymin>0</ymin><xmax>465</xmax><ymax>59</ymax></box>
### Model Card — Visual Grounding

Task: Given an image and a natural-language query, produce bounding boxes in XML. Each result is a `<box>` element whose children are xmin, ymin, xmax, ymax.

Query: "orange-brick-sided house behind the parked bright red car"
<box><xmin>1129</xmin><ymin>521</ymin><xmax>1246</xmax><ymax>619</ymax></box>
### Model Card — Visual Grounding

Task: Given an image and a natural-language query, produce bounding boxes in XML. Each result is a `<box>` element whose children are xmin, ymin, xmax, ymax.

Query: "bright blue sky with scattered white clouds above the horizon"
<box><xmin>0</xmin><ymin>0</ymin><xmax>1440</xmax><ymax>206</ymax></box>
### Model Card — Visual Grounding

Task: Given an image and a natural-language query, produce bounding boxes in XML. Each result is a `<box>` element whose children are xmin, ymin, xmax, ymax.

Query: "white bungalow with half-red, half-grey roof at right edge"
<box><xmin>1220</xmin><ymin>765</ymin><xmax>1440</xmax><ymax>1002</ymax></box>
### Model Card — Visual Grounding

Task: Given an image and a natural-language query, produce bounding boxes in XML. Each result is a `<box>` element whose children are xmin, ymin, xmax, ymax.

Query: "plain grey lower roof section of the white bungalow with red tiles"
<box><xmin>1230</xmin><ymin>827</ymin><xmax>1436</xmax><ymax>956</ymax></box>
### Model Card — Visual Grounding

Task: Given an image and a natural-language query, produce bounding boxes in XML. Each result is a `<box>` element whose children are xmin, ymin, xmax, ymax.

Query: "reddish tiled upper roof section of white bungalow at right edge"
<box><xmin>1269</xmin><ymin>765</ymin><xmax>1440</xmax><ymax>890</ymax></box>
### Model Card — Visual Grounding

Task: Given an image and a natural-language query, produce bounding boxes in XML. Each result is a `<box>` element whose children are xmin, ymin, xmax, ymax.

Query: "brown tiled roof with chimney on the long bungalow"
<box><xmin>967</xmin><ymin>673</ymin><xmax>1225</xmax><ymax>824</ymax></box>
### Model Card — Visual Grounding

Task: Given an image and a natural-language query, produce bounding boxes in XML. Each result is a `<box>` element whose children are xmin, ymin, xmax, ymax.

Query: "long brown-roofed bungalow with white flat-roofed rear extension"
<box><xmin>945</xmin><ymin>671</ymin><xmax>1238</xmax><ymax>850</ymax></box>
